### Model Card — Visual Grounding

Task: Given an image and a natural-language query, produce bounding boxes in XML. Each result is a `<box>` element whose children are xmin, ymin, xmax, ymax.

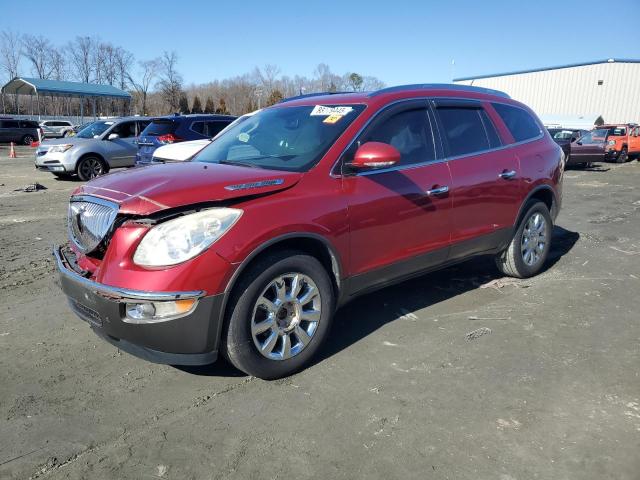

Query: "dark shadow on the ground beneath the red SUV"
<box><xmin>175</xmin><ymin>226</ymin><xmax>580</xmax><ymax>377</ymax></box>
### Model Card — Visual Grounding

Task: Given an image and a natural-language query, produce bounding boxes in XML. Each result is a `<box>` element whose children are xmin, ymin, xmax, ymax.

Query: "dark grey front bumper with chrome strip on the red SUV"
<box><xmin>53</xmin><ymin>246</ymin><xmax>224</xmax><ymax>365</ymax></box>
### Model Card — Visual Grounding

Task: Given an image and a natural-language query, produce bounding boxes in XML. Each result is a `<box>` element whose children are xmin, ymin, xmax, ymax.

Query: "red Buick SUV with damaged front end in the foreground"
<box><xmin>54</xmin><ymin>85</ymin><xmax>564</xmax><ymax>379</ymax></box>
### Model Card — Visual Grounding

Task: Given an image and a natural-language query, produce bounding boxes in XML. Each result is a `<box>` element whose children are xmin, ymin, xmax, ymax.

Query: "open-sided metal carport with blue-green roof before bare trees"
<box><xmin>1</xmin><ymin>77</ymin><xmax>131</xmax><ymax>118</ymax></box>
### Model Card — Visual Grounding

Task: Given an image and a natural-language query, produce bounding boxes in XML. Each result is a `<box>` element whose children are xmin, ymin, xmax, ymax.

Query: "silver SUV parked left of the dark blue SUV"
<box><xmin>35</xmin><ymin>117</ymin><xmax>151</xmax><ymax>181</ymax></box>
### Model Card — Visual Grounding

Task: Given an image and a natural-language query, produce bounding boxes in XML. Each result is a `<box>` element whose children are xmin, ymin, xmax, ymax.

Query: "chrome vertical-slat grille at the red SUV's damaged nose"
<box><xmin>67</xmin><ymin>196</ymin><xmax>118</xmax><ymax>253</ymax></box>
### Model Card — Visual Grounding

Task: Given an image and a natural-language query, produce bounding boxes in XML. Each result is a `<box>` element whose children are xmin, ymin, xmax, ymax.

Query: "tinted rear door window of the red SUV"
<box><xmin>436</xmin><ymin>106</ymin><xmax>500</xmax><ymax>157</ymax></box>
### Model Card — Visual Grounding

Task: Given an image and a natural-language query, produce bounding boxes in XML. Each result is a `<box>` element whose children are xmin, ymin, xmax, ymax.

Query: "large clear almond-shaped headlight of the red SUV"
<box><xmin>133</xmin><ymin>208</ymin><xmax>242</xmax><ymax>267</ymax></box>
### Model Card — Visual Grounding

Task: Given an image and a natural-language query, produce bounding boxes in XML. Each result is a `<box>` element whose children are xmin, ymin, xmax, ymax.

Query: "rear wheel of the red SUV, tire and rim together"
<box><xmin>495</xmin><ymin>200</ymin><xmax>553</xmax><ymax>278</ymax></box>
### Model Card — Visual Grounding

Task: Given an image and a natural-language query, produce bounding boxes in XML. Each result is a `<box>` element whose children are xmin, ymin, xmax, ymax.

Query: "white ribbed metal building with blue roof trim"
<box><xmin>453</xmin><ymin>58</ymin><xmax>640</xmax><ymax>123</ymax></box>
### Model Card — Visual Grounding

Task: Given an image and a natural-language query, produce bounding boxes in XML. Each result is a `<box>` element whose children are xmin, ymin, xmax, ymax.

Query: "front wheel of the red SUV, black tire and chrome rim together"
<box><xmin>222</xmin><ymin>250</ymin><xmax>335</xmax><ymax>380</ymax></box>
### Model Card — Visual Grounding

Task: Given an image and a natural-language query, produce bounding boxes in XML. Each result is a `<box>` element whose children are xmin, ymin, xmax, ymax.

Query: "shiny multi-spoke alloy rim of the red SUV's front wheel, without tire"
<box><xmin>251</xmin><ymin>272</ymin><xmax>322</xmax><ymax>360</ymax></box>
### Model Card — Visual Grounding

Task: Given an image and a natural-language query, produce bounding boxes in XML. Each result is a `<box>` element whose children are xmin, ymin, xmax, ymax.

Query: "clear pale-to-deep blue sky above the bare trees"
<box><xmin>0</xmin><ymin>0</ymin><xmax>640</xmax><ymax>85</ymax></box>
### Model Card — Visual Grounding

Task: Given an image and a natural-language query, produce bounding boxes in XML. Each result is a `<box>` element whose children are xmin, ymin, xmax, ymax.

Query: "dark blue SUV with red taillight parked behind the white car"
<box><xmin>136</xmin><ymin>114</ymin><xmax>236</xmax><ymax>166</ymax></box>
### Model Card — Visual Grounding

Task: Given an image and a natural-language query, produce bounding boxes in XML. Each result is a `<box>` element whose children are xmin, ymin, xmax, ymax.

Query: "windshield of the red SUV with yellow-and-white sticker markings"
<box><xmin>193</xmin><ymin>105</ymin><xmax>364</xmax><ymax>172</ymax></box>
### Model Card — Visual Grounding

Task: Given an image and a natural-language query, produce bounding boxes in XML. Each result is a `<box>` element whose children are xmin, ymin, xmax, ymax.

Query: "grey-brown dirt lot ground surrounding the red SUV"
<box><xmin>0</xmin><ymin>148</ymin><xmax>640</xmax><ymax>480</ymax></box>
